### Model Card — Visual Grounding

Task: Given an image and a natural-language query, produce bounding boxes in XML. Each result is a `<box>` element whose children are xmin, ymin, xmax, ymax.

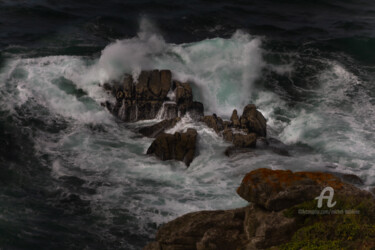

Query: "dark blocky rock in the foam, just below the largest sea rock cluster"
<box><xmin>147</xmin><ymin>129</ymin><xmax>198</xmax><ymax>166</ymax></box>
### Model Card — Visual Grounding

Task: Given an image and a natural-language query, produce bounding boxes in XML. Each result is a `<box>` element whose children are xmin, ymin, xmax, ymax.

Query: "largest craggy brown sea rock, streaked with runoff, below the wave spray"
<box><xmin>103</xmin><ymin>70</ymin><xmax>203</xmax><ymax>122</ymax></box>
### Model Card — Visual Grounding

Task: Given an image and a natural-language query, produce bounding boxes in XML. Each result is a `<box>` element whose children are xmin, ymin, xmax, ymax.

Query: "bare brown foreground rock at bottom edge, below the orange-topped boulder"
<box><xmin>144</xmin><ymin>205</ymin><xmax>296</xmax><ymax>250</ymax></box>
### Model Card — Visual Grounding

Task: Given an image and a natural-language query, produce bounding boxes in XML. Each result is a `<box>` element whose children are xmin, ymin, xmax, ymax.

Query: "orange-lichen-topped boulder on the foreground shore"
<box><xmin>237</xmin><ymin>168</ymin><xmax>368</xmax><ymax>211</ymax></box>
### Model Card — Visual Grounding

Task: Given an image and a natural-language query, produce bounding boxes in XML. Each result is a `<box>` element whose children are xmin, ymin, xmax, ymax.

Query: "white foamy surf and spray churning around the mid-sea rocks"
<box><xmin>0</xmin><ymin>20</ymin><xmax>375</xmax><ymax>249</ymax></box>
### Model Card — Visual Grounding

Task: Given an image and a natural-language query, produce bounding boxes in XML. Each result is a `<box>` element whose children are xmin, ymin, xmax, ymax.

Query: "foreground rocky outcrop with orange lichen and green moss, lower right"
<box><xmin>144</xmin><ymin>169</ymin><xmax>375</xmax><ymax>250</ymax></box>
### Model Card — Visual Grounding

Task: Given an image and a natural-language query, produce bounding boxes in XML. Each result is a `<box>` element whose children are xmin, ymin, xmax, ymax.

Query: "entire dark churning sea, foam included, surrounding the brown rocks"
<box><xmin>0</xmin><ymin>0</ymin><xmax>375</xmax><ymax>249</ymax></box>
